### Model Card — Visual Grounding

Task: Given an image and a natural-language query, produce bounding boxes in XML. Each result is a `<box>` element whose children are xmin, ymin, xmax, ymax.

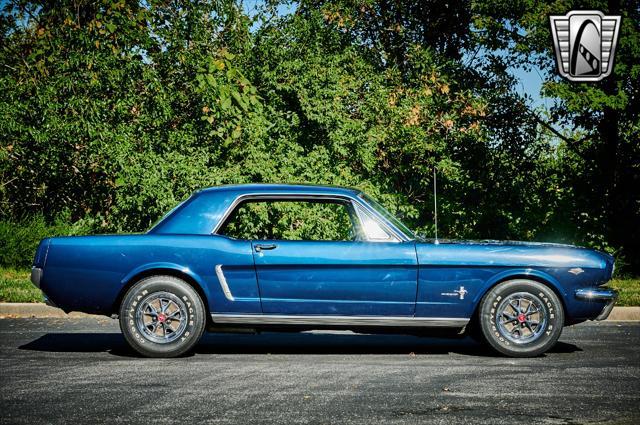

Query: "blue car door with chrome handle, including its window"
<box><xmin>220</xmin><ymin>197</ymin><xmax>417</xmax><ymax>316</ymax></box>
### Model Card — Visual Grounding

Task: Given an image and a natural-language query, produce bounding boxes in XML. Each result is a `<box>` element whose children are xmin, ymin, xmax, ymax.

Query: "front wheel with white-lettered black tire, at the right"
<box><xmin>478</xmin><ymin>279</ymin><xmax>564</xmax><ymax>357</ymax></box>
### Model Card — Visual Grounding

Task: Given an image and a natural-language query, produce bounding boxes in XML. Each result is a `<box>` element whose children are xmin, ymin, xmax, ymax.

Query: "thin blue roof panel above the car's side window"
<box><xmin>196</xmin><ymin>183</ymin><xmax>361</xmax><ymax>196</ymax></box>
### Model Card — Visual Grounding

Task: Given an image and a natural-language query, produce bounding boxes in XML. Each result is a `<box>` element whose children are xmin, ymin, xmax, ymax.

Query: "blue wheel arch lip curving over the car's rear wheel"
<box><xmin>111</xmin><ymin>263</ymin><xmax>211</xmax><ymax>323</ymax></box>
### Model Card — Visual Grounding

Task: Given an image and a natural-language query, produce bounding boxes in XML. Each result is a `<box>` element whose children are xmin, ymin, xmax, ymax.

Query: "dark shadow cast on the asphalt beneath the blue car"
<box><xmin>19</xmin><ymin>332</ymin><xmax>582</xmax><ymax>357</ymax></box>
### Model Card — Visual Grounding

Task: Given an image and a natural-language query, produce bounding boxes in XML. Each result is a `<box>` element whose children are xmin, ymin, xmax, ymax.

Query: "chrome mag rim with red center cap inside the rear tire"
<box><xmin>135</xmin><ymin>292</ymin><xmax>188</xmax><ymax>344</ymax></box>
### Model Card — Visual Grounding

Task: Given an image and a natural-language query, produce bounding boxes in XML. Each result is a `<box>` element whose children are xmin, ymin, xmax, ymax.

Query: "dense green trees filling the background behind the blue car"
<box><xmin>0</xmin><ymin>0</ymin><xmax>640</xmax><ymax>271</ymax></box>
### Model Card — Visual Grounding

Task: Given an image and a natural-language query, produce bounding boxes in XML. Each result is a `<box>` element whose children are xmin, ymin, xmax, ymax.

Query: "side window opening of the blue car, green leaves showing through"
<box><xmin>219</xmin><ymin>199</ymin><xmax>358</xmax><ymax>241</ymax></box>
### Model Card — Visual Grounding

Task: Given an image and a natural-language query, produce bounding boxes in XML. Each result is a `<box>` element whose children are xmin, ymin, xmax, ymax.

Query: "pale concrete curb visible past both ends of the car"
<box><xmin>0</xmin><ymin>303</ymin><xmax>640</xmax><ymax>322</ymax></box>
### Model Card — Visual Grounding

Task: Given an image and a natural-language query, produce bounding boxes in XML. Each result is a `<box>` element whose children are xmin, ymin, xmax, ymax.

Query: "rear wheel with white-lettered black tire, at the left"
<box><xmin>120</xmin><ymin>276</ymin><xmax>206</xmax><ymax>357</ymax></box>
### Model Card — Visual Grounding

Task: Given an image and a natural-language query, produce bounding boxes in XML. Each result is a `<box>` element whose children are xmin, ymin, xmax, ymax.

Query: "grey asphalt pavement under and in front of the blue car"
<box><xmin>0</xmin><ymin>318</ymin><xmax>640</xmax><ymax>425</ymax></box>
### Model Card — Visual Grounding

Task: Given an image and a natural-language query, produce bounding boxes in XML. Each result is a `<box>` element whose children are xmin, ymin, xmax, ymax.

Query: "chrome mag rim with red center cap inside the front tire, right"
<box><xmin>495</xmin><ymin>292</ymin><xmax>548</xmax><ymax>344</ymax></box>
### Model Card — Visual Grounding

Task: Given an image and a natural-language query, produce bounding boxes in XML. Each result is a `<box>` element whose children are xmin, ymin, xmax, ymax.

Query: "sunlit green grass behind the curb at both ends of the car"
<box><xmin>0</xmin><ymin>267</ymin><xmax>640</xmax><ymax>306</ymax></box>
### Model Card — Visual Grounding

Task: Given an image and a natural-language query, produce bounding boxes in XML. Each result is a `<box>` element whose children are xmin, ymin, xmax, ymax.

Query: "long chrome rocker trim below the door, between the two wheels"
<box><xmin>211</xmin><ymin>313</ymin><xmax>469</xmax><ymax>328</ymax></box>
